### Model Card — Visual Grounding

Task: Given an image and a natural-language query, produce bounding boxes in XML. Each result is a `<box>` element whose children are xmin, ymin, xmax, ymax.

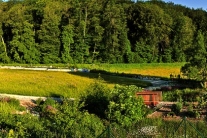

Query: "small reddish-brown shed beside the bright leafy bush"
<box><xmin>136</xmin><ymin>91</ymin><xmax>162</xmax><ymax>106</ymax></box>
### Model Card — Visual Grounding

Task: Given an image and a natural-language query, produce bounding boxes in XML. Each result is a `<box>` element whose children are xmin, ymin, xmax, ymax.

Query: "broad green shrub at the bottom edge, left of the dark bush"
<box><xmin>44</xmin><ymin>99</ymin><xmax>104</xmax><ymax>138</ymax></box>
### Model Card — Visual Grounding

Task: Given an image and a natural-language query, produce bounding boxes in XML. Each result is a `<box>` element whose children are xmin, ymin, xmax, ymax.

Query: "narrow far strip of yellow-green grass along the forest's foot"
<box><xmin>0</xmin><ymin>63</ymin><xmax>185</xmax><ymax>78</ymax></box>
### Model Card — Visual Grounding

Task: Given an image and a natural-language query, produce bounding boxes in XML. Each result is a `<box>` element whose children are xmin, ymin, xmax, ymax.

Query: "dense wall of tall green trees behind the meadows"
<box><xmin>0</xmin><ymin>0</ymin><xmax>207</xmax><ymax>64</ymax></box>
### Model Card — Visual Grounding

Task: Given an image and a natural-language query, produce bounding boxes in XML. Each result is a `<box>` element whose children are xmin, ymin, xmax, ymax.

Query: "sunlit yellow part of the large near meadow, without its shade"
<box><xmin>0</xmin><ymin>69</ymin><xmax>93</xmax><ymax>97</ymax></box>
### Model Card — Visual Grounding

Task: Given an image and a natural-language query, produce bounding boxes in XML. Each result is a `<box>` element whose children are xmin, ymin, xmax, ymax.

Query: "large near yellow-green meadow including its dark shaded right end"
<box><xmin>0</xmin><ymin>69</ymin><xmax>149</xmax><ymax>98</ymax></box>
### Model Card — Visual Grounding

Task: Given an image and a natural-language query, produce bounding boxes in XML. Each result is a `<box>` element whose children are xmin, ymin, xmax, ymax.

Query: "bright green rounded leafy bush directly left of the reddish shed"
<box><xmin>108</xmin><ymin>85</ymin><xmax>145</xmax><ymax>126</ymax></box>
